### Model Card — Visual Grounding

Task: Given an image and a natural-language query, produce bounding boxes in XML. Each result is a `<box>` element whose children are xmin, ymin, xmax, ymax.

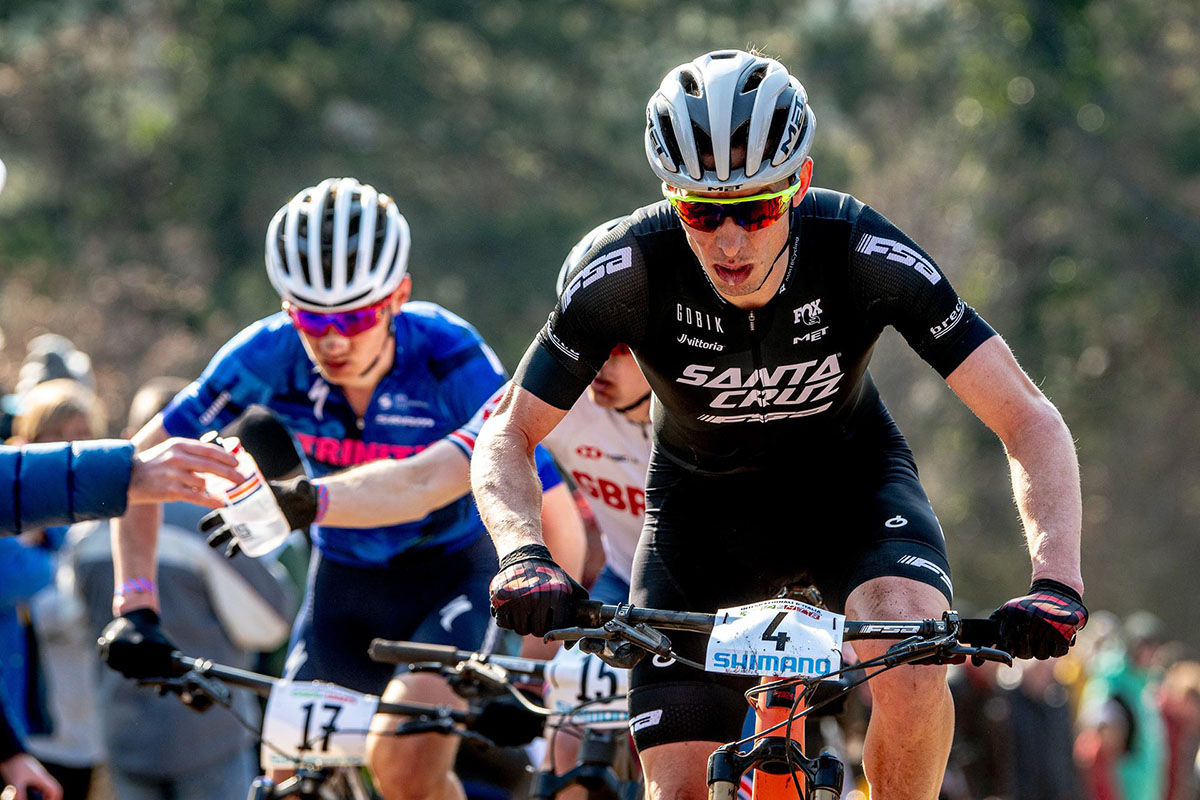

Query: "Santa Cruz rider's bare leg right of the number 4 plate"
<box><xmin>846</xmin><ymin>577</ymin><xmax>954</xmax><ymax>800</ymax></box>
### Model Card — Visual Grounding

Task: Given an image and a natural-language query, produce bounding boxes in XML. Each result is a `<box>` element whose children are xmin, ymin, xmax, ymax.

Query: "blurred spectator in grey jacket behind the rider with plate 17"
<box><xmin>68</xmin><ymin>380</ymin><xmax>293</xmax><ymax>800</ymax></box>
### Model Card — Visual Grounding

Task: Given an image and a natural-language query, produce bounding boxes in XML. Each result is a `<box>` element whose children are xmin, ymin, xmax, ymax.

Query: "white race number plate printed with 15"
<box><xmin>545</xmin><ymin>648</ymin><xmax>629</xmax><ymax>730</ymax></box>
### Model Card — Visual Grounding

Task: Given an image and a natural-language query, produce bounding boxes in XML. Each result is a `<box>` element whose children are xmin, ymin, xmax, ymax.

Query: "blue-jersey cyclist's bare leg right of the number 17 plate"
<box><xmin>367</xmin><ymin>674</ymin><xmax>467</xmax><ymax>800</ymax></box>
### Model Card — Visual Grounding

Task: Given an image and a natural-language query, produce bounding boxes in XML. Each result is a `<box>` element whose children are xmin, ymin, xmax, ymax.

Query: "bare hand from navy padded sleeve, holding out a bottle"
<box><xmin>130</xmin><ymin>438</ymin><xmax>246</xmax><ymax>509</ymax></box>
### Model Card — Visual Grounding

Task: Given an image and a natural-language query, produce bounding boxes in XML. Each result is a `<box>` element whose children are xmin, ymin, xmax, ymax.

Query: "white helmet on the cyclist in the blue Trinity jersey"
<box><xmin>266</xmin><ymin>178</ymin><xmax>410</xmax><ymax>313</ymax></box>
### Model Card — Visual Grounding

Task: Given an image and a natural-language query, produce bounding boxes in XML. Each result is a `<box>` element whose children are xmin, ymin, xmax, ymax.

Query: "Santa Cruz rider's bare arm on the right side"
<box><xmin>946</xmin><ymin>336</ymin><xmax>1084</xmax><ymax>593</ymax></box>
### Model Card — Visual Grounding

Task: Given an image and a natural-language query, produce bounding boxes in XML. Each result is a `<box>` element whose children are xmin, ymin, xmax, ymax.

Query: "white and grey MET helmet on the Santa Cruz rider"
<box><xmin>646</xmin><ymin>50</ymin><xmax>816</xmax><ymax>192</ymax></box>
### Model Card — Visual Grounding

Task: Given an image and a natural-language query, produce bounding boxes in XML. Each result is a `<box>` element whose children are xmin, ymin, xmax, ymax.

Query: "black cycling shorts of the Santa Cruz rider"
<box><xmin>629</xmin><ymin>446</ymin><xmax>953</xmax><ymax>750</ymax></box>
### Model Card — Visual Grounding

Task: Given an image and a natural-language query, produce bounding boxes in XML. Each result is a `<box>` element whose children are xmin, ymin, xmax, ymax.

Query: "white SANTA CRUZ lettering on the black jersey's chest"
<box><xmin>676</xmin><ymin>354</ymin><xmax>845</xmax><ymax>423</ymax></box>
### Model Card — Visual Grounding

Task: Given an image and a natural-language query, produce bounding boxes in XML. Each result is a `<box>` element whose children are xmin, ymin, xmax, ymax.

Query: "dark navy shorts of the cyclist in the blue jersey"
<box><xmin>284</xmin><ymin>536</ymin><xmax>497</xmax><ymax>694</ymax></box>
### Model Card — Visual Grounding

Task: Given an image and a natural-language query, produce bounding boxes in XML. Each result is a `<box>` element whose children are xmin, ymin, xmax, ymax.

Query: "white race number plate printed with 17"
<box><xmin>260</xmin><ymin>680</ymin><xmax>379</xmax><ymax>769</ymax></box>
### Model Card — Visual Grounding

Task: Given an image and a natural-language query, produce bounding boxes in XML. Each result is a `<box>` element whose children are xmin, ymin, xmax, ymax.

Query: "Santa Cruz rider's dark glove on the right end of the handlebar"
<box><xmin>991</xmin><ymin>578</ymin><xmax>1087</xmax><ymax>658</ymax></box>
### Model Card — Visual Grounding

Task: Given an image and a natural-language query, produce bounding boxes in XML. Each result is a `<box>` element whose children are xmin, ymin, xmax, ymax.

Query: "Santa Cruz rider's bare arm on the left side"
<box><xmin>470</xmin><ymin>385</ymin><xmax>566</xmax><ymax>558</ymax></box>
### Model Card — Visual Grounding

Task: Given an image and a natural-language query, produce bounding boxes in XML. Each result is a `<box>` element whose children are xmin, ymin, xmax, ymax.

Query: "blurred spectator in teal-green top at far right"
<box><xmin>1075</xmin><ymin>612</ymin><xmax>1166</xmax><ymax>800</ymax></box>
